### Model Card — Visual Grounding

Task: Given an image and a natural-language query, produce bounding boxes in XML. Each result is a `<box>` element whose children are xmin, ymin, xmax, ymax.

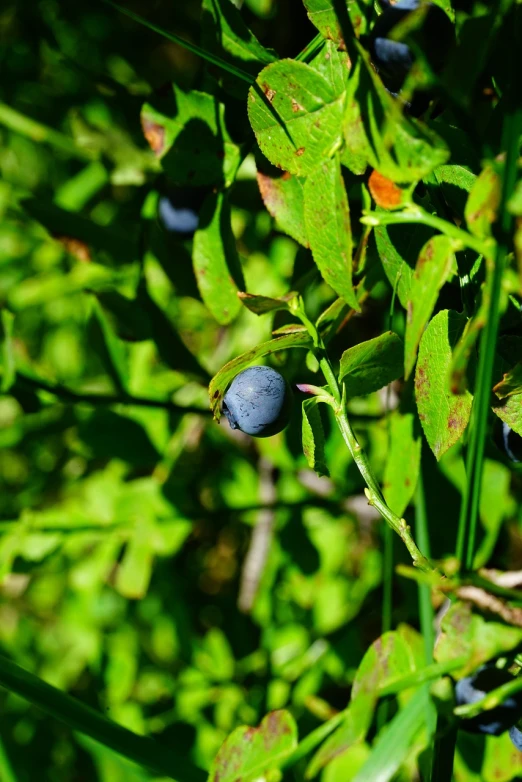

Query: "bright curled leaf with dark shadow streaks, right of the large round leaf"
<box><xmin>343</xmin><ymin>52</ymin><xmax>449</xmax><ymax>184</ymax></box>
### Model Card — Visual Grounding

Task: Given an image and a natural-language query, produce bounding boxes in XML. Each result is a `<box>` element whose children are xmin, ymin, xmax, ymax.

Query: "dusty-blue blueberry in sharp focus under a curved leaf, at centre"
<box><xmin>223</xmin><ymin>367</ymin><xmax>293</xmax><ymax>437</ymax></box>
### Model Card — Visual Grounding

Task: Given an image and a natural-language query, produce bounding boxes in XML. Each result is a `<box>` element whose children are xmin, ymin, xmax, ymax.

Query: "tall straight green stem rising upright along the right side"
<box><xmin>457</xmin><ymin>105</ymin><xmax>522</xmax><ymax>570</ymax></box>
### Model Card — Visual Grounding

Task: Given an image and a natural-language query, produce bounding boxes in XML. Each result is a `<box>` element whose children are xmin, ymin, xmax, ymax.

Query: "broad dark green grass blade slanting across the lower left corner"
<box><xmin>0</xmin><ymin>656</ymin><xmax>206</xmax><ymax>782</ymax></box>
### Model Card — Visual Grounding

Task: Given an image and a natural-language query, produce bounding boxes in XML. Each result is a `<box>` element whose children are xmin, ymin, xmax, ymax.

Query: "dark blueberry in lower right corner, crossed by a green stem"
<box><xmin>455</xmin><ymin>665</ymin><xmax>522</xmax><ymax>736</ymax></box>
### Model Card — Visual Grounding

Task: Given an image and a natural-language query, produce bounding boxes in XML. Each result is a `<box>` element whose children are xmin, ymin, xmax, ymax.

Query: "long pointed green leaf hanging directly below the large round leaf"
<box><xmin>304</xmin><ymin>156</ymin><xmax>360</xmax><ymax>310</ymax></box>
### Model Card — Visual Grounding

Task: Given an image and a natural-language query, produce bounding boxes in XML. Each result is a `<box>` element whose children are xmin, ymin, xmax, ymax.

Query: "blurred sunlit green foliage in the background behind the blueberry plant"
<box><xmin>0</xmin><ymin>0</ymin><xmax>522</xmax><ymax>782</ymax></box>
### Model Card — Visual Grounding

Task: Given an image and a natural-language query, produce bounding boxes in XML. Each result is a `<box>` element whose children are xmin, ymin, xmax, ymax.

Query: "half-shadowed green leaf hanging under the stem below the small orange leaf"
<box><xmin>374</xmin><ymin>220</ymin><xmax>434</xmax><ymax>309</ymax></box>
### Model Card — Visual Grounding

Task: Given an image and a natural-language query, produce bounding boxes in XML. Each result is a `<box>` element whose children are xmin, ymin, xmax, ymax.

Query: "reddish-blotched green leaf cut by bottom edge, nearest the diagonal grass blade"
<box><xmin>208</xmin><ymin>710</ymin><xmax>297</xmax><ymax>782</ymax></box>
